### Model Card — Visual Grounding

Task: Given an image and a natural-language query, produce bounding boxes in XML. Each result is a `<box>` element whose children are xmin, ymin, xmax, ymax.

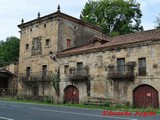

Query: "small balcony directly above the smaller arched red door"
<box><xmin>69</xmin><ymin>68</ymin><xmax>88</xmax><ymax>80</ymax></box>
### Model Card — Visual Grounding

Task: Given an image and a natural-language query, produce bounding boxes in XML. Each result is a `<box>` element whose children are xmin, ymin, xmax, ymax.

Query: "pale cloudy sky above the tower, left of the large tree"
<box><xmin>0</xmin><ymin>0</ymin><xmax>85</xmax><ymax>40</ymax></box>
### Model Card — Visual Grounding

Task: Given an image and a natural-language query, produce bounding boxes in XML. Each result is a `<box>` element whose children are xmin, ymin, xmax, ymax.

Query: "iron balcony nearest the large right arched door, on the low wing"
<box><xmin>108</xmin><ymin>65</ymin><xmax>134</xmax><ymax>80</ymax></box>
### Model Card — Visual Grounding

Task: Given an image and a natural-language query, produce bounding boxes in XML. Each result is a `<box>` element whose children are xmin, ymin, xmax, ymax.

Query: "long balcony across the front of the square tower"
<box><xmin>19</xmin><ymin>71</ymin><xmax>53</xmax><ymax>82</ymax></box>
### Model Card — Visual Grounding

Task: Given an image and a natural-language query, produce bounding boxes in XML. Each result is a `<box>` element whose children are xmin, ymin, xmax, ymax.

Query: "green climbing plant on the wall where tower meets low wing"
<box><xmin>52</xmin><ymin>70</ymin><xmax>60</xmax><ymax>96</ymax></box>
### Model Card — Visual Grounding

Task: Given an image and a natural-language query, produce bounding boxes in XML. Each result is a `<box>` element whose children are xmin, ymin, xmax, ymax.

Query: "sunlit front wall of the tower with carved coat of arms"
<box><xmin>18</xmin><ymin>19</ymin><xmax>59</xmax><ymax>95</ymax></box>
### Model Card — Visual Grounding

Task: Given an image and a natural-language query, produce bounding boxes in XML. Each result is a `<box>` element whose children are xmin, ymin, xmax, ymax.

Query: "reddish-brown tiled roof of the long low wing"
<box><xmin>58</xmin><ymin>29</ymin><xmax>160</xmax><ymax>56</ymax></box>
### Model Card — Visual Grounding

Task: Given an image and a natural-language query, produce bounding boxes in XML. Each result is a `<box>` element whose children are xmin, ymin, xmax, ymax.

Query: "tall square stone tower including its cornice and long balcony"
<box><xmin>18</xmin><ymin>11</ymin><xmax>103</xmax><ymax>96</ymax></box>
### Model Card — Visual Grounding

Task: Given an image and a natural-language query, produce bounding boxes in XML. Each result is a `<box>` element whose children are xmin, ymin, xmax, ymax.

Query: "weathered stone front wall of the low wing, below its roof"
<box><xmin>59</xmin><ymin>41</ymin><xmax>160</xmax><ymax>103</ymax></box>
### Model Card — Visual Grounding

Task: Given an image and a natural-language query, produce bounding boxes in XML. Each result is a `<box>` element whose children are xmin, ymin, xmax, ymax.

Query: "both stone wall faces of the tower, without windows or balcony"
<box><xmin>18</xmin><ymin>17</ymin><xmax>102</xmax><ymax>96</ymax></box>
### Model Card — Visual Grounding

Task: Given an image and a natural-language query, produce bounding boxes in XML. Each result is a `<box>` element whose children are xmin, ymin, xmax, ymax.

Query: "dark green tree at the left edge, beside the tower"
<box><xmin>0</xmin><ymin>37</ymin><xmax>20</xmax><ymax>67</ymax></box>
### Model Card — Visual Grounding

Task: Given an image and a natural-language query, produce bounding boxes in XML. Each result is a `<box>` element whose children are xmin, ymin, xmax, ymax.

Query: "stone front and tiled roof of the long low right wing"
<box><xmin>58</xmin><ymin>29</ymin><xmax>160</xmax><ymax>107</ymax></box>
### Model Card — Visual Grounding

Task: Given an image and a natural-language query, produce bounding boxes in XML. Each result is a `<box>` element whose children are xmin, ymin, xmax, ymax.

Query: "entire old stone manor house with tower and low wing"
<box><xmin>18</xmin><ymin>8</ymin><xmax>160</xmax><ymax>108</ymax></box>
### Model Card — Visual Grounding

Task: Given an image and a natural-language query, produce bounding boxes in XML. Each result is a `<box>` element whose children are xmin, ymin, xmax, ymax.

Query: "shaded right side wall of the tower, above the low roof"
<box><xmin>58</xmin><ymin>18</ymin><xmax>102</xmax><ymax>50</ymax></box>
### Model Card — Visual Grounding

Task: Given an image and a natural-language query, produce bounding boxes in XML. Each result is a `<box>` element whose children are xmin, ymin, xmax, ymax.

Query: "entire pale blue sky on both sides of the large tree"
<box><xmin>0</xmin><ymin>0</ymin><xmax>160</xmax><ymax>40</ymax></box>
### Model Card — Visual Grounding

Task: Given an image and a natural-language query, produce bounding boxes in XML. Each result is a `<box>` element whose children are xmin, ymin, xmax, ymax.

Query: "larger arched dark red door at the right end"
<box><xmin>133</xmin><ymin>85</ymin><xmax>159</xmax><ymax>108</ymax></box>
